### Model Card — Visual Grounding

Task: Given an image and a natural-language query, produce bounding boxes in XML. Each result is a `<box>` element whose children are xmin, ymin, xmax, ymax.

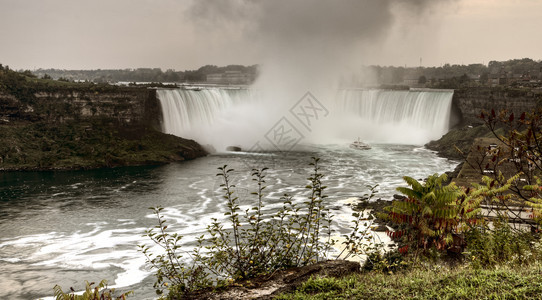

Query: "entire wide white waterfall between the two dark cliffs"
<box><xmin>158</xmin><ymin>88</ymin><xmax>453</xmax><ymax>151</ymax></box>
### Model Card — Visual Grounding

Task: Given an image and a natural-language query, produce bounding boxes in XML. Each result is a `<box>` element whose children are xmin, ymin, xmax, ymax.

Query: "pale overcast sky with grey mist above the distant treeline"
<box><xmin>0</xmin><ymin>0</ymin><xmax>542</xmax><ymax>70</ymax></box>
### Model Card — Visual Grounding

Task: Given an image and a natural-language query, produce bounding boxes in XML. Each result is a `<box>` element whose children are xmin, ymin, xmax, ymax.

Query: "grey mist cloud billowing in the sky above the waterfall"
<box><xmin>187</xmin><ymin>0</ymin><xmax>453</xmax><ymax>88</ymax></box>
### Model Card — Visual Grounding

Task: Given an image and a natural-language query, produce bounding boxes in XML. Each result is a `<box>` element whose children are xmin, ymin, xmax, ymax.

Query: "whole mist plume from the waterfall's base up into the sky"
<box><xmin>183</xmin><ymin>0</ymin><xmax>460</xmax><ymax>149</ymax></box>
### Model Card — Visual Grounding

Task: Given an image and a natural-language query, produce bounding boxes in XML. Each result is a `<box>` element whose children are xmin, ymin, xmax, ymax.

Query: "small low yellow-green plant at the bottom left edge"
<box><xmin>53</xmin><ymin>280</ymin><xmax>133</xmax><ymax>300</ymax></box>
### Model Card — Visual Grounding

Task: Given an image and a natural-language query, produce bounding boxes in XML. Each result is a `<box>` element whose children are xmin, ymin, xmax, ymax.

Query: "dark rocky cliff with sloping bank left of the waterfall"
<box><xmin>0</xmin><ymin>87</ymin><xmax>206</xmax><ymax>171</ymax></box>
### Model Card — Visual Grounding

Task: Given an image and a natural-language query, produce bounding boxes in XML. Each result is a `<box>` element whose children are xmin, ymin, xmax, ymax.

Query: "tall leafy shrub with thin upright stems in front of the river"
<box><xmin>208</xmin><ymin>158</ymin><xmax>331</xmax><ymax>280</ymax></box>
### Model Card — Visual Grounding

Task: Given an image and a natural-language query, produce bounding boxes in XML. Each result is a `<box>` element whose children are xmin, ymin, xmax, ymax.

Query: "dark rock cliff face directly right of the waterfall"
<box><xmin>453</xmin><ymin>87</ymin><xmax>542</xmax><ymax>125</ymax></box>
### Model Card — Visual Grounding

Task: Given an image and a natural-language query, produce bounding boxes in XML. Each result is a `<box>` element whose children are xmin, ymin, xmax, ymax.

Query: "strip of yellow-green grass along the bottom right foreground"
<box><xmin>274</xmin><ymin>262</ymin><xmax>542</xmax><ymax>300</ymax></box>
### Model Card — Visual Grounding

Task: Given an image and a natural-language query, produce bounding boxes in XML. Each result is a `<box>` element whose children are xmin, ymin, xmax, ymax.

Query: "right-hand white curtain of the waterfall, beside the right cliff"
<box><xmin>336</xmin><ymin>89</ymin><xmax>453</xmax><ymax>144</ymax></box>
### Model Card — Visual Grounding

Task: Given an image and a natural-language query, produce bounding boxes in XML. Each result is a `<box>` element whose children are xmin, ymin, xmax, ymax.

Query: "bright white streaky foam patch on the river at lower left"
<box><xmin>0</xmin><ymin>219</ymin><xmax>150</xmax><ymax>299</ymax></box>
